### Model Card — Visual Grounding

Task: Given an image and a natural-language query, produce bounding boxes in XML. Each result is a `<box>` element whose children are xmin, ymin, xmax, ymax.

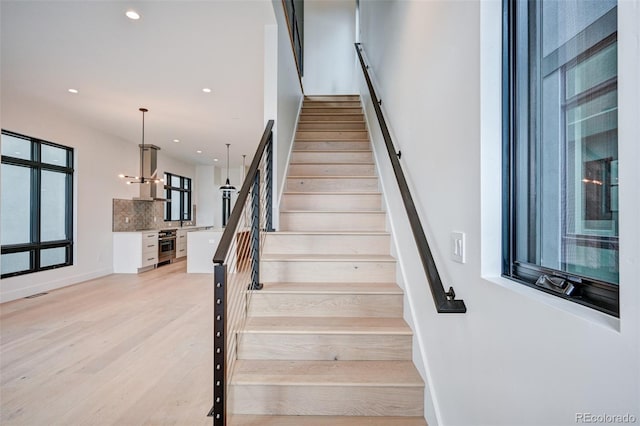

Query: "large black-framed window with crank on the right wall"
<box><xmin>503</xmin><ymin>0</ymin><xmax>619</xmax><ymax>316</ymax></box>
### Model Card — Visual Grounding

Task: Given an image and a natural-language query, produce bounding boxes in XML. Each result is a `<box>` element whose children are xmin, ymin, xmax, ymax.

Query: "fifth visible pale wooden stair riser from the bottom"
<box><xmin>264</xmin><ymin>232</ymin><xmax>391</xmax><ymax>255</ymax></box>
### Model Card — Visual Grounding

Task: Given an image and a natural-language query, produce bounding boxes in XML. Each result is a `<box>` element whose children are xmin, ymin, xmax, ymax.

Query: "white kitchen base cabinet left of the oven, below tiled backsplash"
<box><xmin>113</xmin><ymin>231</ymin><xmax>158</xmax><ymax>274</ymax></box>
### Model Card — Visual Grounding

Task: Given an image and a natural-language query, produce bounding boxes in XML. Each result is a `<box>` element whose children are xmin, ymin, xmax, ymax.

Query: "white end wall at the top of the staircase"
<box><xmin>303</xmin><ymin>0</ymin><xmax>357</xmax><ymax>95</ymax></box>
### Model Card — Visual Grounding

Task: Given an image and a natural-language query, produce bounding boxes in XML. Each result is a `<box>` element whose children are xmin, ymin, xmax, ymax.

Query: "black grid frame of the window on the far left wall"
<box><xmin>0</xmin><ymin>129</ymin><xmax>74</xmax><ymax>279</ymax></box>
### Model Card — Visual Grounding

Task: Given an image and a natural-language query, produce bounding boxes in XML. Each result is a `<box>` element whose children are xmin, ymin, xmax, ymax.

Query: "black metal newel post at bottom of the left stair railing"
<box><xmin>209</xmin><ymin>263</ymin><xmax>227</xmax><ymax>426</ymax></box>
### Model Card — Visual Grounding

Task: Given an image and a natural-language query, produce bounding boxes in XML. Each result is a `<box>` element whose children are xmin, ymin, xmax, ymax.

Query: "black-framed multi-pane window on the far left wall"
<box><xmin>0</xmin><ymin>130</ymin><xmax>73</xmax><ymax>278</ymax></box>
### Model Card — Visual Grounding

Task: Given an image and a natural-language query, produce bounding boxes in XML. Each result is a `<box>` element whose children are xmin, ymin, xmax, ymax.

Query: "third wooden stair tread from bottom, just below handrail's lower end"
<box><xmin>241</xmin><ymin>317</ymin><xmax>413</xmax><ymax>336</ymax></box>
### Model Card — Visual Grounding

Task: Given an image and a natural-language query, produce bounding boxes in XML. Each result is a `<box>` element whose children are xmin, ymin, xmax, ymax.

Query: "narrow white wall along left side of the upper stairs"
<box><xmin>272</xmin><ymin>0</ymin><xmax>303</xmax><ymax>225</ymax></box>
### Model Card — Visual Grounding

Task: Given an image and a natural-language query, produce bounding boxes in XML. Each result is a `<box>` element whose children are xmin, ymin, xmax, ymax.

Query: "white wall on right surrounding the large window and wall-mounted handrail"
<box><xmin>360</xmin><ymin>0</ymin><xmax>640</xmax><ymax>425</ymax></box>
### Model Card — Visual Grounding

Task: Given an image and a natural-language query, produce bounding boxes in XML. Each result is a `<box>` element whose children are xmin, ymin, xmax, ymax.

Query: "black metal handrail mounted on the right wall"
<box><xmin>355</xmin><ymin>43</ymin><xmax>467</xmax><ymax>314</ymax></box>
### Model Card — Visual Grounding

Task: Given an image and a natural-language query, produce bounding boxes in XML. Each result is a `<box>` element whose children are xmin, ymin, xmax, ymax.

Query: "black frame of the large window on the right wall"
<box><xmin>502</xmin><ymin>0</ymin><xmax>620</xmax><ymax>317</ymax></box>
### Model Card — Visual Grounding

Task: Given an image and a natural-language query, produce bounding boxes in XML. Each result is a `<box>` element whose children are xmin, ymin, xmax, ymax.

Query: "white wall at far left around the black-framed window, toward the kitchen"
<box><xmin>0</xmin><ymin>100</ymin><xmax>195</xmax><ymax>302</ymax></box>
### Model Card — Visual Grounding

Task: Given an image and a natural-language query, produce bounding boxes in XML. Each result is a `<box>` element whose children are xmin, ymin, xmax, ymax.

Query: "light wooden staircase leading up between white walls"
<box><xmin>227</xmin><ymin>96</ymin><xmax>426</xmax><ymax>426</ymax></box>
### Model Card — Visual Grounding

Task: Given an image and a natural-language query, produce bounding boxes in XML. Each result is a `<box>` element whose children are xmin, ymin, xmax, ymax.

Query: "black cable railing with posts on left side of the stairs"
<box><xmin>209</xmin><ymin>120</ymin><xmax>273</xmax><ymax>426</ymax></box>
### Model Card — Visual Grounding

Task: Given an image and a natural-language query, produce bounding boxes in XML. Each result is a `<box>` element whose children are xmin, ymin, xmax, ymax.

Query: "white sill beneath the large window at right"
<box><xmin>482</xmin><ymin>276</ymin><xmax>620</xmax><ymax>332</ymax></box>
